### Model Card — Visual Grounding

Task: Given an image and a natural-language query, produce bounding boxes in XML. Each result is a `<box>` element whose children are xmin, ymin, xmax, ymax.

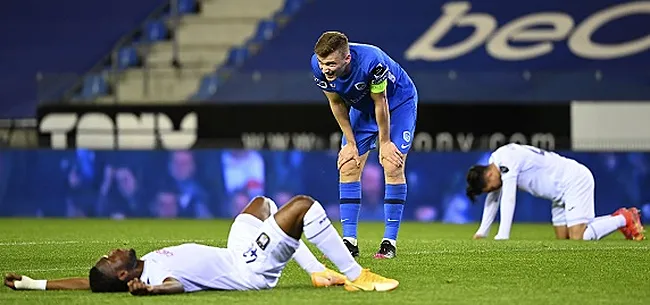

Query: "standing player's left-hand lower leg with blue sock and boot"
<box><xmin>339</xmin><ymin>153</ymin><xmax>368</xmax><ymax>257</ymax></box>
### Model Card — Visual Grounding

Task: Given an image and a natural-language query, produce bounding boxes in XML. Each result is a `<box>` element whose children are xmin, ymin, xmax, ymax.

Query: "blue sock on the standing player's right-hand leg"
<box><xmin>384</xmin><ymin>184</ymin><xmax>406</xmax><ymax>241</ymax></box>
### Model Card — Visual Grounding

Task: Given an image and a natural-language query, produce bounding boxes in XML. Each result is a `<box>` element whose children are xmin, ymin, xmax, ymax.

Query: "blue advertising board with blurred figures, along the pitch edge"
<box><xmin>0</xmin><ymin>150</ymin><xmax>650</xmax><ymax>223</ymax></box>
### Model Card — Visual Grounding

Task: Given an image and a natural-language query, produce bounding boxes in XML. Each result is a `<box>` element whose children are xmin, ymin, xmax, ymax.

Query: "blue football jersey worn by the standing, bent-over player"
<box><xmin>311</xmin><ymin>43</ymin><xmax>417</xmax><ymax>113</ymax></box>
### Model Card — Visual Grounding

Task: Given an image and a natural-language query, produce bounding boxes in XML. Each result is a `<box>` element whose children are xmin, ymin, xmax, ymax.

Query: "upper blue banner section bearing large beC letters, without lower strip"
<box><xmin>244</xmin><ymin>0</ymin><xmax>650</xmax><ymax>72</ymax></box>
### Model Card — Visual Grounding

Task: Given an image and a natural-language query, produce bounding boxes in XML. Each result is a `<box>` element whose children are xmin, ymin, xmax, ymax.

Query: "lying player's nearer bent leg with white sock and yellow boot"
<box><xmin>273</xmin><ymin>196</ymin><xmax>399</xmax><ymax>291</ymax></box>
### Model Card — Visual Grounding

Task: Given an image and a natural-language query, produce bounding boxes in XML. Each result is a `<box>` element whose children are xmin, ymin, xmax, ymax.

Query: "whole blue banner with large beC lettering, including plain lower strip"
<box><xmin>215</xmin><ymin>0</ymin><xmax>650</xmax><ymax>103</ymax></box>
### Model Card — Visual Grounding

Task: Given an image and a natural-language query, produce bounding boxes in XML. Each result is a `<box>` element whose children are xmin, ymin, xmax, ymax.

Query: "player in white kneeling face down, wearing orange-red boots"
<box><xmin>467</xmin><ymin>144</ymin><xmax>645</xmax><ymax>240</ymax></box>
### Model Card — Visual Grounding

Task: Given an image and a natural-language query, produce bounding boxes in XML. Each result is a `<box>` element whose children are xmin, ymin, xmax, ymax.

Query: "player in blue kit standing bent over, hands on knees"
<box><xmin>311</xmin><ymin>32</ymin><xmax>418</xmax><ymax>258</ymax></box>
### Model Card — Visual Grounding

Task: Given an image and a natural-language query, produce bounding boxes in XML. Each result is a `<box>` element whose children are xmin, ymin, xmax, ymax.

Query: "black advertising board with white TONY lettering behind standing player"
<box><xmin>38</xmin><ymin>104</ymin><xmax>571</xmax><ymax>152</ymax></box>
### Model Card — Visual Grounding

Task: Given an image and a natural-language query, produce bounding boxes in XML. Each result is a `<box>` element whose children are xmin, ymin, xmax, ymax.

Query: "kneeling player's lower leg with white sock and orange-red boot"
<box><xmin>568</xmin><ymin>208</ymin><xmax>645</xmax><ymax>240</ymax></box>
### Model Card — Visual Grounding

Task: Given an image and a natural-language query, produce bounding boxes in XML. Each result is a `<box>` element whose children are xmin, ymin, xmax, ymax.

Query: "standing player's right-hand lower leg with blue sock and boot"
<box><xmin>375</xmin><ymin>154</ymin><xmax>407</xmax><ymax>259</ymax></box>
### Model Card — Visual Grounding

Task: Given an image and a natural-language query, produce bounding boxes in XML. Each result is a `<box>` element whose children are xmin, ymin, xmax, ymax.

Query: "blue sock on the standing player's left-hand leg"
<box><xmin>339</xmin><ymin>181</ymin><xmax>361</xmax><ymax>239</ymax></box>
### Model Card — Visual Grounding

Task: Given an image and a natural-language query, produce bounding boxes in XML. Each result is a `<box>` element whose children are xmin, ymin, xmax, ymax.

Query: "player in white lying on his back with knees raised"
<box><xmin>5</xmin><ymin>196</ymin><xmax>399</xmax><ymax>295</ymax></box>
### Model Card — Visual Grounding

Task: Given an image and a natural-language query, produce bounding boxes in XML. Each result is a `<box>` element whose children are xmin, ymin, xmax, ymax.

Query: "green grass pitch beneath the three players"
<box><xmin>0</xmin><ymin>219</ymin><xmax>650</xmax><ymax>305</ymax></box>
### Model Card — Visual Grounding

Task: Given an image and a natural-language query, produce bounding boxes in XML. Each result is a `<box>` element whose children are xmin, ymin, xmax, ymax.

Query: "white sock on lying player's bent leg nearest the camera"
<box><xmin>303</xmin><ymin>201</ymin><xmax>361</xmax><ymax>281</ymax></box>
